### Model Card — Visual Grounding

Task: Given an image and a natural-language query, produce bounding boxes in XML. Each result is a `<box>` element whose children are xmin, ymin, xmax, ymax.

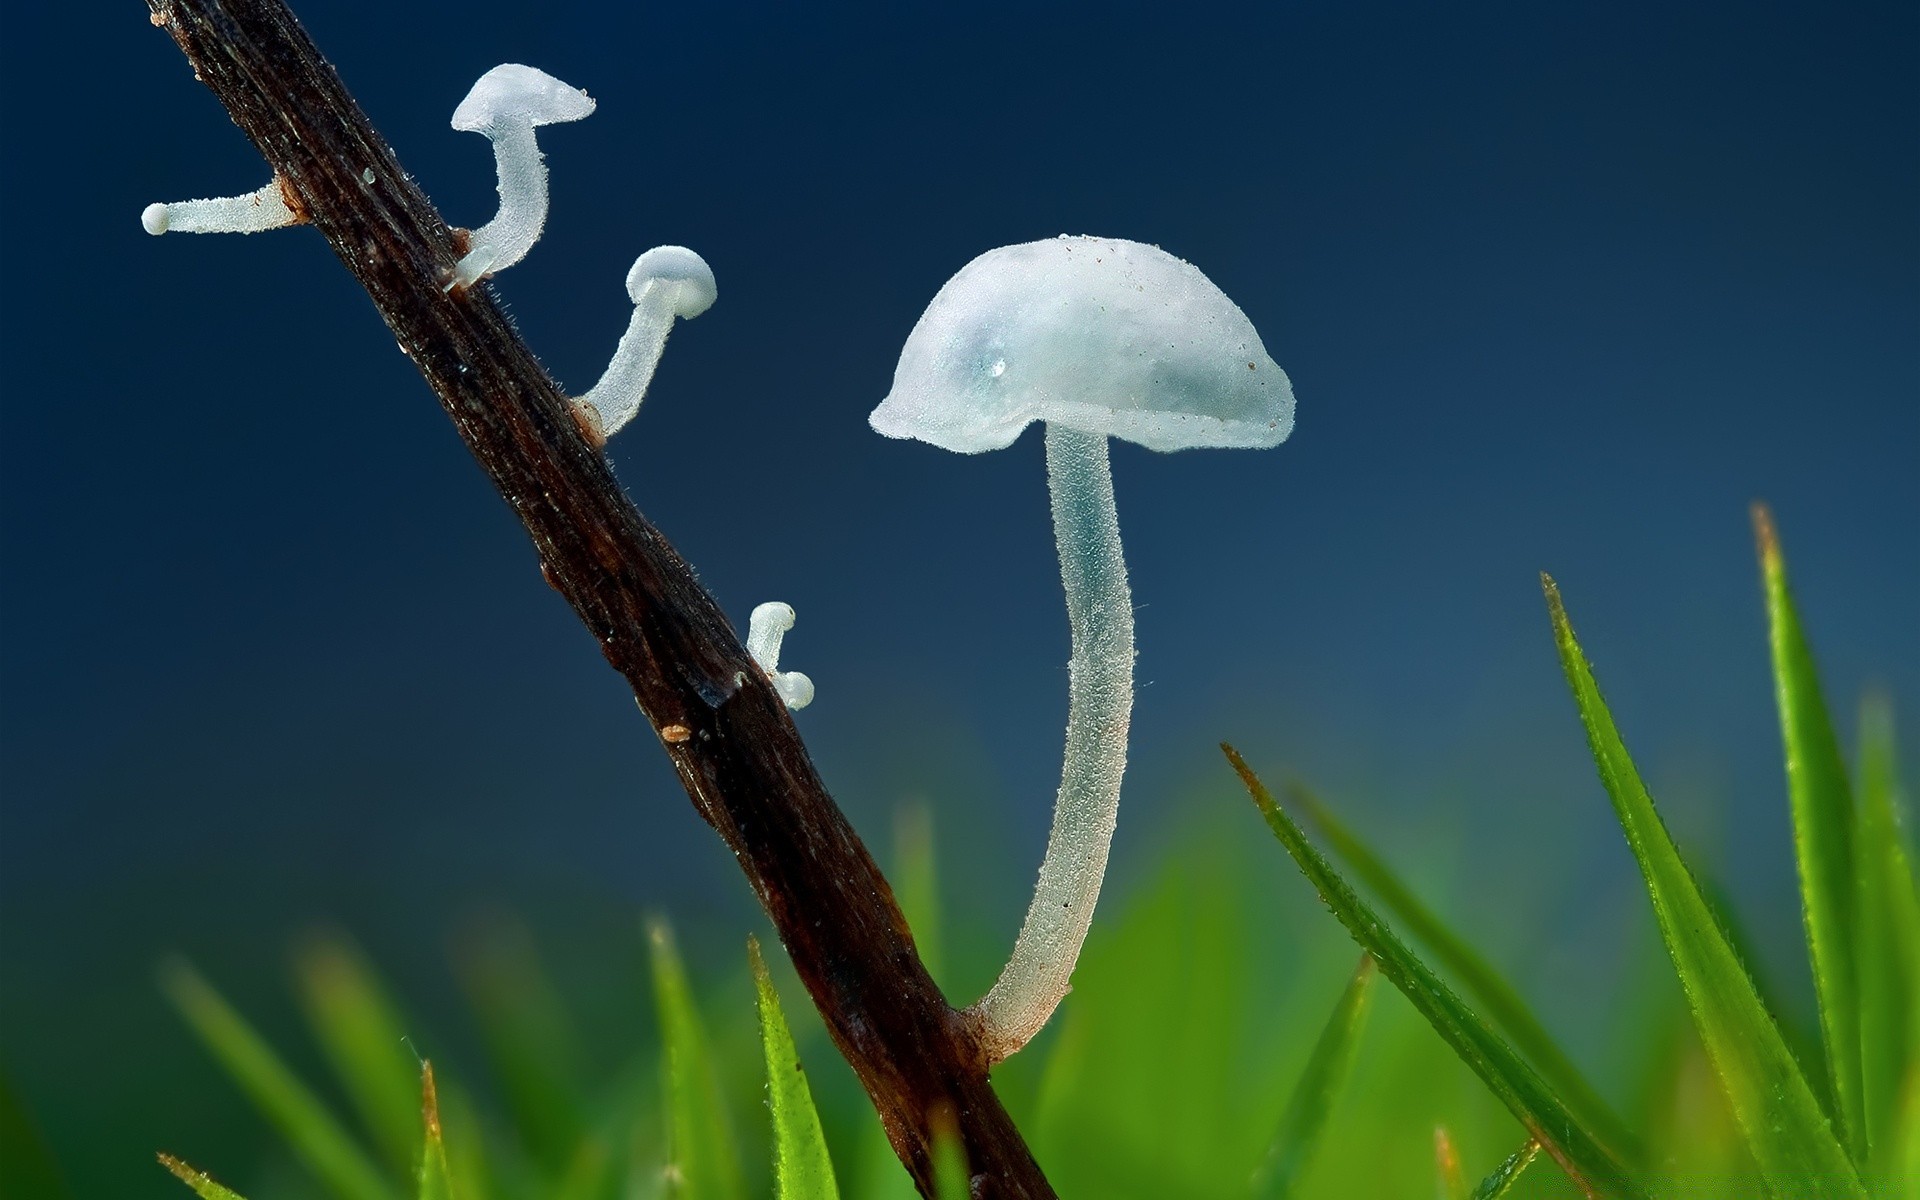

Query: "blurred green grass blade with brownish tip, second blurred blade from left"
<box><xmin>294</xmin><ymin>933</ymin><xmax>420</xmax><ymax>1175</ymax></box>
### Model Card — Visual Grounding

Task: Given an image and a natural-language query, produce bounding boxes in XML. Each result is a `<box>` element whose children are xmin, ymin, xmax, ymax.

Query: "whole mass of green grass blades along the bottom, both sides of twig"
<box><xmin>33</xmin><ymin>506</ymin><xmax>1920</xmax><ymax>1200</ymax></box>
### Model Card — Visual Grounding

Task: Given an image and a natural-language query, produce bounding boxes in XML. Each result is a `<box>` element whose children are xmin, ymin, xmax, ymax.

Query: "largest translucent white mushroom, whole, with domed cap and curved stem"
<box><xmin>868</xmin><ymin>236</ymin><xmax>1294</xmax><ymax>1062</ymax></box>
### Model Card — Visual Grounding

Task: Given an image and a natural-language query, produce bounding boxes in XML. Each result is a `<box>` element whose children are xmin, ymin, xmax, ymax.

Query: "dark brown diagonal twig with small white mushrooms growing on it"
<box><xmin>150</xmin><ymin>0</ymin><xmax>1054</xmax><ymax>1198</ymax></box>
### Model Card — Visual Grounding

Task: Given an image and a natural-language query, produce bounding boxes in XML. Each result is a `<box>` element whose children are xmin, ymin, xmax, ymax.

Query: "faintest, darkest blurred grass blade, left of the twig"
<box><xmin>459</xmin><ymin>920</ymin><xmax>588</xmax><ymax>1179</ymax></box>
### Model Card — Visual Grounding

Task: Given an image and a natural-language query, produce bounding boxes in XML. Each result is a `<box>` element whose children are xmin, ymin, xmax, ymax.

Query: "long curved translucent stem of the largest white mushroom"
<box><xmin>966</xmin><ymin>422</ymin><xmax>1133</xmax><ymax>1064</ymax></box>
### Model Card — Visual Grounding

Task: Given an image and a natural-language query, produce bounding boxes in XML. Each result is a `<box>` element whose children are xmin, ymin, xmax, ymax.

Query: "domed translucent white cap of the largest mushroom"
<box><xmin>868</xmin><ymin>234</ymin><xmax>1294</xmax><ymax>453</ymax></box>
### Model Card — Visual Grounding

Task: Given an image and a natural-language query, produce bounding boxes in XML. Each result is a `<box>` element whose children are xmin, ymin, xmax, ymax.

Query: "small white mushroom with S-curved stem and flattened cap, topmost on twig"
<box><xmin>449</xmin><ymin>63</ymin><xmax>593</xmax><ymax>290</ymax></box>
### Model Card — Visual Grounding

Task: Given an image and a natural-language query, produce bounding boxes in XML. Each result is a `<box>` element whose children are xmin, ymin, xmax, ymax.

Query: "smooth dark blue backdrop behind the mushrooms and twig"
<box><xmin>0</xmin><ymin>0</ymin><xmax>1920</xmax><ymax>1188</ymax></box>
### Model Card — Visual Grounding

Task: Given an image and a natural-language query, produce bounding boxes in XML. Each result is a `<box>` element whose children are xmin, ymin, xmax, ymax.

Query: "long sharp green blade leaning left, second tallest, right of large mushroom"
<box><xmin>1540</xmin><ymin>576</ymin><xmax>1866</xmax><ymax>1198</ymax></box>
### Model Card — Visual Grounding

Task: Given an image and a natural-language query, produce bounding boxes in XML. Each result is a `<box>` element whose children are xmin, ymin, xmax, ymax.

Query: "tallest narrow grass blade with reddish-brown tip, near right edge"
<box><xmin>1753</xmin><ymin>503</ymin><xmax>1866</xmax><ymax>1162</ymax></box>
